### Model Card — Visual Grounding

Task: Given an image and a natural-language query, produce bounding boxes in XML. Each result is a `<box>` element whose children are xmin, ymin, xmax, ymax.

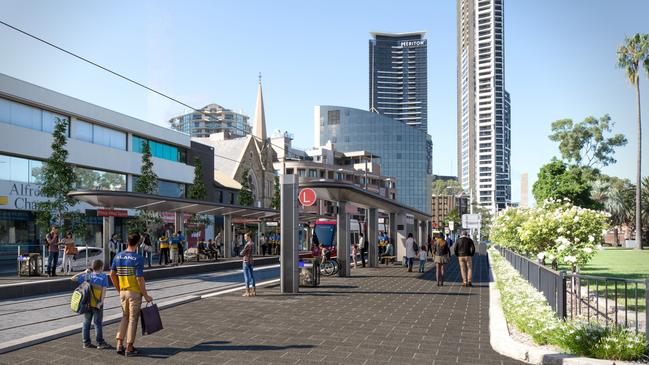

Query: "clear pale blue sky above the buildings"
<box><xmin>0</xmin><ymin>0</ymin><xmax>649</xmax><ymax>205</ymax></box>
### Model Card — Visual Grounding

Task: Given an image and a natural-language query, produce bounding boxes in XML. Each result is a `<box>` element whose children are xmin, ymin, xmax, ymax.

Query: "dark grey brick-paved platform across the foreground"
<box><xmin>0</xmin><ymin>256</ymin><xmax>519</xmax><ymax>365</ymax></box>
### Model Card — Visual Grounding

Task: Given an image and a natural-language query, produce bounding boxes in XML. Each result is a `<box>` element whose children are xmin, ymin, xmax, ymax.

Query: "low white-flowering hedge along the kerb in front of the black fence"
<box><xmin>489</xmin><ymin>248</ymin><xmax>649</xmax><ymax>361</ymax></box>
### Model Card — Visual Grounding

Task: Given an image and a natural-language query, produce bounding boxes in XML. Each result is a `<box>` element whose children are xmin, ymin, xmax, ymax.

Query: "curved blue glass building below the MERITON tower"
<box><xmin>314</xmin><ymin>105</ymin><xmax>432</xmax><ymax>212</ymax></box>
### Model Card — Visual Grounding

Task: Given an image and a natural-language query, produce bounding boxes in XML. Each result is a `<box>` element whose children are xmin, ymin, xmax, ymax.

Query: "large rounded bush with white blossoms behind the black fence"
<box><xmin>491</xmin><ymin>200</ymin><xmax>609</xmax><ymax>267</ymax></box>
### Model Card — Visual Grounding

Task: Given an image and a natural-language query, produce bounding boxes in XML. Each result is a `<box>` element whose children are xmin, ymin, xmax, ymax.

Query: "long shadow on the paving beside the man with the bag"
<box><xmin>139</xmin><ymin>341</ymin><xmax>315</xmax><ymax>359</ymax></box>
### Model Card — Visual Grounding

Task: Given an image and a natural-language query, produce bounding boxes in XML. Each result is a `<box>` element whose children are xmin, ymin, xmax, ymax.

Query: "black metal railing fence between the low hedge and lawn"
<box><xmin>496</xmin><ymin>247</ymin><xmax>649</xmax><ymax>338</ymax></box>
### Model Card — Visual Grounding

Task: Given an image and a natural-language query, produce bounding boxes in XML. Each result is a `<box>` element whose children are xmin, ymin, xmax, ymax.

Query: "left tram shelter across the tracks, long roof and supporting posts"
<box><xmin>68</xmin><ymin>190</ymin><xmax>279</xmax><ymax>268</ymax></box>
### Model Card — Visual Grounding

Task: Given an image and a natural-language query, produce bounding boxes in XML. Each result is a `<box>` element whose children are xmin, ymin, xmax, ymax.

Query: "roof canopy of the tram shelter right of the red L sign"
<box><xmin>300</xmin><ymin>180</ymin><xmax>432</xmax><ymax>221</ymax></box>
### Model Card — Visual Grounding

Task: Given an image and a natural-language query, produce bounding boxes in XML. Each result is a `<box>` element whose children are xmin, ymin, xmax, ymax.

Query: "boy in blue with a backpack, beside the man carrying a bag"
<box><xmin>71</xmin><ymin>260</ymin><xmax>113</xmax><ymax>350</ymax></box>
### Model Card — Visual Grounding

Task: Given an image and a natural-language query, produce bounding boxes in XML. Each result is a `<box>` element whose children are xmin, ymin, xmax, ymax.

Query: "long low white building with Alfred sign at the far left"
<box><xmin>0</xmin><ymin>74</ymin><xmax>194</xmax><ymax>266</ymax></box>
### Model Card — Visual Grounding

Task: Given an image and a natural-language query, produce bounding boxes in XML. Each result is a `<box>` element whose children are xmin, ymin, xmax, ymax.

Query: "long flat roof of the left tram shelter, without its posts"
<box><xmin>68</xmin><ymin>190</ymin><xmax>279</xmax><ymax>220</ymax></box>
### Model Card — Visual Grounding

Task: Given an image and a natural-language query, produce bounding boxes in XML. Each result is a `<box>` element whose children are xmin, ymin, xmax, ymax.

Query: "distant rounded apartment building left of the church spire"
<box><xmin>169</xmin><ymin>104</ymin><xmax>252</xmax><ymax>138</ymax></box>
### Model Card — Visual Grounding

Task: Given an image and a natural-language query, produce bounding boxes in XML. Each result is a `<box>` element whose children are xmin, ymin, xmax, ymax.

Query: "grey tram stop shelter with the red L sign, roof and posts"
<box><xmin>280</xmin><ymin>175</ymin><xmax>432</xmax><ymax>293</ymax></box>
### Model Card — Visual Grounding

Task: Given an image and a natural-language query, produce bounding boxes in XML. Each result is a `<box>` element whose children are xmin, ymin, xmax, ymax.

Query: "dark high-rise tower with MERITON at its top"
<box><xmin>369</xmin><ymin>32</ymin><xmax>428</xmax><ymax>132</ymax></box>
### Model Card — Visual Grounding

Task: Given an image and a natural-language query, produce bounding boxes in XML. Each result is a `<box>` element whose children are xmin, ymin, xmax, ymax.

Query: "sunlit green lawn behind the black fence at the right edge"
<box><xmin>581</xmin><ymin>248</ymin><xmax>649</xmax><ymax>311</ymax></box>
